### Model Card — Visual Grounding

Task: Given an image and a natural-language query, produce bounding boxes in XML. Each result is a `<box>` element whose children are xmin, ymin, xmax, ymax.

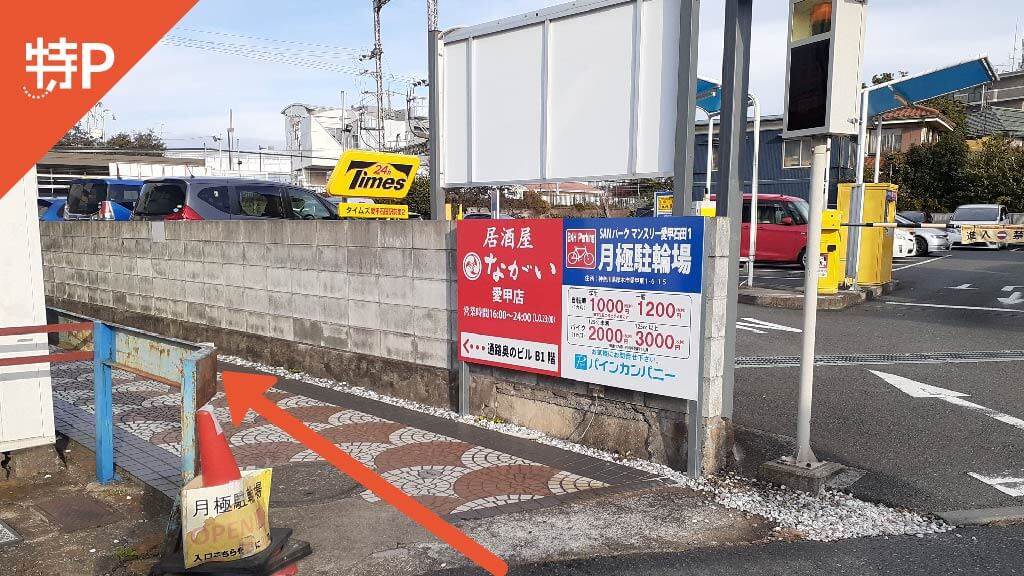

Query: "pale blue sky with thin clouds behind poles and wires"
<box><xmin>97</xmin><ymin>0</ymin><xmax>1024</xmax><ymax>150</ymax></box>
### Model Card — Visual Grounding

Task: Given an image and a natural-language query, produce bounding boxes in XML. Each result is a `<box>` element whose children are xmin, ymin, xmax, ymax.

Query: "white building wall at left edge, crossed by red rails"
<box><xmin>0</xmin><ymin>168</ymin><xmax>54</xmax><ymax>452</ymax></box>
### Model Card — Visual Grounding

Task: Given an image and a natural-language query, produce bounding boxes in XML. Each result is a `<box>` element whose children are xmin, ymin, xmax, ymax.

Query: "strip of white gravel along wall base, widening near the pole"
<box><xmin>219</xmin><ymin>355</ymin><xmax>954</xmax><ymax>541</ymax></box>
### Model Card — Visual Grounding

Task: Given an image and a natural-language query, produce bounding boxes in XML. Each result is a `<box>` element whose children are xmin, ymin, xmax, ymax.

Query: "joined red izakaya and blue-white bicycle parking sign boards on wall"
<box><xmin>457</xmin><ymin>216</ymin><xmax>705</xmax><ymax>400</ymax></box>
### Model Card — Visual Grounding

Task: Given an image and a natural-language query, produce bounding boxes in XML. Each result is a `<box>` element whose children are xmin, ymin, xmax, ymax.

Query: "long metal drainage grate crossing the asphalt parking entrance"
<box><xmin>736</xmin><ymin>349</ymin><xmax>1024</xmax><ymax>368</ymax></box>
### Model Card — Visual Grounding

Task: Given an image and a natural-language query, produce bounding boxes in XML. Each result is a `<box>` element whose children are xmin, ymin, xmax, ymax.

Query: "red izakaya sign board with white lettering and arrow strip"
<box><xmin>457</xmin><ymin>219</ymin><xmax>562</xmax><ymax>376</ymax></box>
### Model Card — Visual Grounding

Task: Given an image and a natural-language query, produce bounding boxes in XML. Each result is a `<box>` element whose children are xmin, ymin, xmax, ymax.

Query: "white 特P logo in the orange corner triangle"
<box><xmin>22</xmin><ymin>36</ymin><xmax>114</xmax><ymax>99</ymax></box>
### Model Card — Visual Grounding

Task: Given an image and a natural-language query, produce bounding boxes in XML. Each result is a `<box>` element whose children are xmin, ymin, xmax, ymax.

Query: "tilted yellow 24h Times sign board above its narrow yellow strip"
<box><xmin>327</xmin><ymin>150</ymin><xmax>420</xmax><ymax>198</ymax></box>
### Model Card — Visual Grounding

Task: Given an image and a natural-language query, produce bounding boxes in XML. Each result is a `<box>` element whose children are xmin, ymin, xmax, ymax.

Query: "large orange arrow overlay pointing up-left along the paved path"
<box><xmin>221</xmin><ymin>372</ymin><xmax>509</xmax><ymax>576</ymax></box>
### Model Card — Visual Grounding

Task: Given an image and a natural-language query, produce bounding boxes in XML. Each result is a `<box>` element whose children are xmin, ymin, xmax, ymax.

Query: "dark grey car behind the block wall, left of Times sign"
<box><xmin>132</xmin><ymin>177</ymin><xmax>338</xmax><ymax>220</ymax></box>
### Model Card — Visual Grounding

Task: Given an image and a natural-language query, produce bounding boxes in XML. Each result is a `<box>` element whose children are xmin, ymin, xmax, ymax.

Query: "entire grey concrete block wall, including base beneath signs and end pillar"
<box><xmin>40</xmin><ymin>218</ymin><xmax>731</xmax><ymax>471</ymax></box>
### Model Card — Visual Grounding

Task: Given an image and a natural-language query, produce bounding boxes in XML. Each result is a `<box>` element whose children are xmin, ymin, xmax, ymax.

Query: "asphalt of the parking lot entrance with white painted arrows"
<box><xmin>734</xmin><ymin>249</ymin><xmax>1024</xmax><ymax>512</ymax></box>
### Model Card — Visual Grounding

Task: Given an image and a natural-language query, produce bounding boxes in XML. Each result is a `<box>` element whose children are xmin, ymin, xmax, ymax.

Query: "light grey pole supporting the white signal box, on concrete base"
<box><xmin>796</xmin><ymin>136</ymin><xmax>831</xmax><ymax>464</ymax></box>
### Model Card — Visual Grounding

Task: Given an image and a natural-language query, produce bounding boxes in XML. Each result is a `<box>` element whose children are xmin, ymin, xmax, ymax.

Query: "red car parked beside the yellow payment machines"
<box><xmin>711</xmin><ymin>194</ymin><xmax>808</xmax><ymax>264</ymax></box>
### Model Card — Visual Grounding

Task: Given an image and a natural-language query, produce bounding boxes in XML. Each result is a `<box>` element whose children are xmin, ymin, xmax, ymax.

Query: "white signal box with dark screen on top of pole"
<box><xmin>782</xmin><ymin>0</ymin><xmax>865</xmax><ymax>138</ymax></box>
